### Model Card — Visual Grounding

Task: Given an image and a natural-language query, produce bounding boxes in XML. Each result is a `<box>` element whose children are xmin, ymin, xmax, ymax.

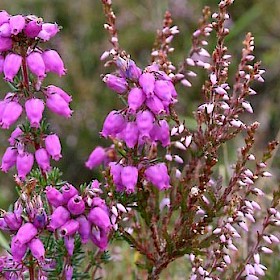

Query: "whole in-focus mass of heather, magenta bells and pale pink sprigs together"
<box><xmin>0</xmin><ymin>0</ymin><xmax>280</xmax><ymax>280</ymax></box>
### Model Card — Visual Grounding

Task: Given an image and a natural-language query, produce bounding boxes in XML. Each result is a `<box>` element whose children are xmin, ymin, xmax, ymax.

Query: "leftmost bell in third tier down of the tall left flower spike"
<box><xmin>0</xmin><ymin>101</ymin><xmax>22</xmax><ymax>129</ymax></box>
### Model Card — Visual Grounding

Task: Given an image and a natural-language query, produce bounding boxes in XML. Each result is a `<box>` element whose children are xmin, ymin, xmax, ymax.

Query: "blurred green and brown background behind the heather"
<box><xmin>0</xmin><ymin>0</ymin><xmax>280</xmax><ymax>279</ymax></box>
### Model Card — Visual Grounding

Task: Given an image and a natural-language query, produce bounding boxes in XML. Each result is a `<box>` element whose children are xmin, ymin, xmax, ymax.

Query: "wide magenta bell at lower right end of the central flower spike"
<box><xmin>145</xmin><ymin>163</ymin><xmax>170</xmax><ymax>190</ymax></box>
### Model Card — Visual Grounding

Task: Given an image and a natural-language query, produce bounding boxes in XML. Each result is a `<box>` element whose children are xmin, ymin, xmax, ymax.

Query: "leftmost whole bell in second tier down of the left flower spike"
<box><xmin>3</xmin><ymin>53</ymin><xmax>22</xmax><ymax>82</ymax></box>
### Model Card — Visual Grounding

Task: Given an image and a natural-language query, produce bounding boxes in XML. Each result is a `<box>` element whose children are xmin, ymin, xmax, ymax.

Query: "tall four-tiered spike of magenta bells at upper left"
<box><xmin>0</xmin><ymin>11</ymin><xmax>72</xmax><ymax>179</ymax></box>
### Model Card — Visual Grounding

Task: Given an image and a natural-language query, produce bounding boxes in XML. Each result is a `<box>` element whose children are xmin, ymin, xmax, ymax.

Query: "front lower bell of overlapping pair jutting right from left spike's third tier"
<box><xmin>46</xmin><ymin>93</ymin><xmax>73</xmax><ymax>118</ymax></box>
